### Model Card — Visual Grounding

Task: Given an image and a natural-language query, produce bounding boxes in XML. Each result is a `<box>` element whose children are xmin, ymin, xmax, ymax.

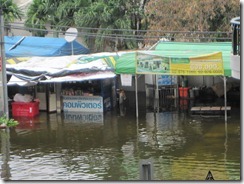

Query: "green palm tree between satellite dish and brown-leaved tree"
<box><xmin>74</xmin><ymin>0</ymin><xmax>146</xmax><ymax>51</ymax></box>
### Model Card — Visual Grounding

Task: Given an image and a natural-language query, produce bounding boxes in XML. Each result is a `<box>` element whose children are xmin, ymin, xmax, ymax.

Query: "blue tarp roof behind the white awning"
<box><xmin>4</xmin><ymin>36</ymin><xmax>90</xmax><ymax>58</ymax></box>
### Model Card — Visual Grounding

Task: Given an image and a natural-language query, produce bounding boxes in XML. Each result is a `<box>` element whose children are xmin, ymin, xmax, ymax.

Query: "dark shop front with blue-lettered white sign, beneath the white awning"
<box><xmin>61</xmin><ymin>78</ymin><xmax>116</xmax><ymax>116</ymax></box>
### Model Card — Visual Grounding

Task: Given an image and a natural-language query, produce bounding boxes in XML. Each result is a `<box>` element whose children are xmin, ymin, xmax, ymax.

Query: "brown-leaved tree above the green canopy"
<box><xmin>146</xmin><ymin>0</ymin><xmax>240</xmax><ymax>43</ymax></box>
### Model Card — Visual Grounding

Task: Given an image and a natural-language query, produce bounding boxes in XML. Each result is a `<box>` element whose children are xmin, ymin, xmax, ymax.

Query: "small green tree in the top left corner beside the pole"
<box><xmin>0</xmin><ymin>0</ymin><xmax>24</xmax><ymax>35</ymax></box>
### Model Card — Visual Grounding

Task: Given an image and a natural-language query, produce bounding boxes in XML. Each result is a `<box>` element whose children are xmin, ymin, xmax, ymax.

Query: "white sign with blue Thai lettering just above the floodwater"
<box><xmin>63</xmin><ymin>96</ymin><xmax>103</xmax><ymax>112</ymax></box>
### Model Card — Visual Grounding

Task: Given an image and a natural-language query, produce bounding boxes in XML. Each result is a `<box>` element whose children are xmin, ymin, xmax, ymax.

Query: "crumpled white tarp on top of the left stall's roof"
<box><xmin>6</xmin><ymin>54</ymin><xmax>113</xmax><ymax>76</ymax></box>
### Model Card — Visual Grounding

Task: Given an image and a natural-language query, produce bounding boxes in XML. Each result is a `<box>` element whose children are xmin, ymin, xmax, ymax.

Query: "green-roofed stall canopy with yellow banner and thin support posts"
<box><xmin>115</xmin><ymin>41</ymin><xmax>231</xmax><ymax>122</ymax></box>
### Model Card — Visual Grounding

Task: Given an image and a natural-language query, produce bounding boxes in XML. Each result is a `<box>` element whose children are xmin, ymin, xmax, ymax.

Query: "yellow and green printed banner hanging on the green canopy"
<box><xmin>136</xmin><ymin>52</ymin><xmax>224</xmax><ymax>75</ymax></box>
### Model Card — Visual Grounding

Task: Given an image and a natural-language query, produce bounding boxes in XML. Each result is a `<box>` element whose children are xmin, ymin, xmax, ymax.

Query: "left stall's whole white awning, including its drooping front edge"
<box><xmin>6</xmin><ymin>53</ymin><xmax>117</xmax><ymax>85</ymax></box>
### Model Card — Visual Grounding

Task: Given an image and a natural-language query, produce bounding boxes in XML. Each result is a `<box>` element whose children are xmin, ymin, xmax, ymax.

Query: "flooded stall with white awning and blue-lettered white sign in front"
<box><xmin>7</xmin><ymin>53</ymin><xmax>116</xmax><ymax>118</ymax></box>
